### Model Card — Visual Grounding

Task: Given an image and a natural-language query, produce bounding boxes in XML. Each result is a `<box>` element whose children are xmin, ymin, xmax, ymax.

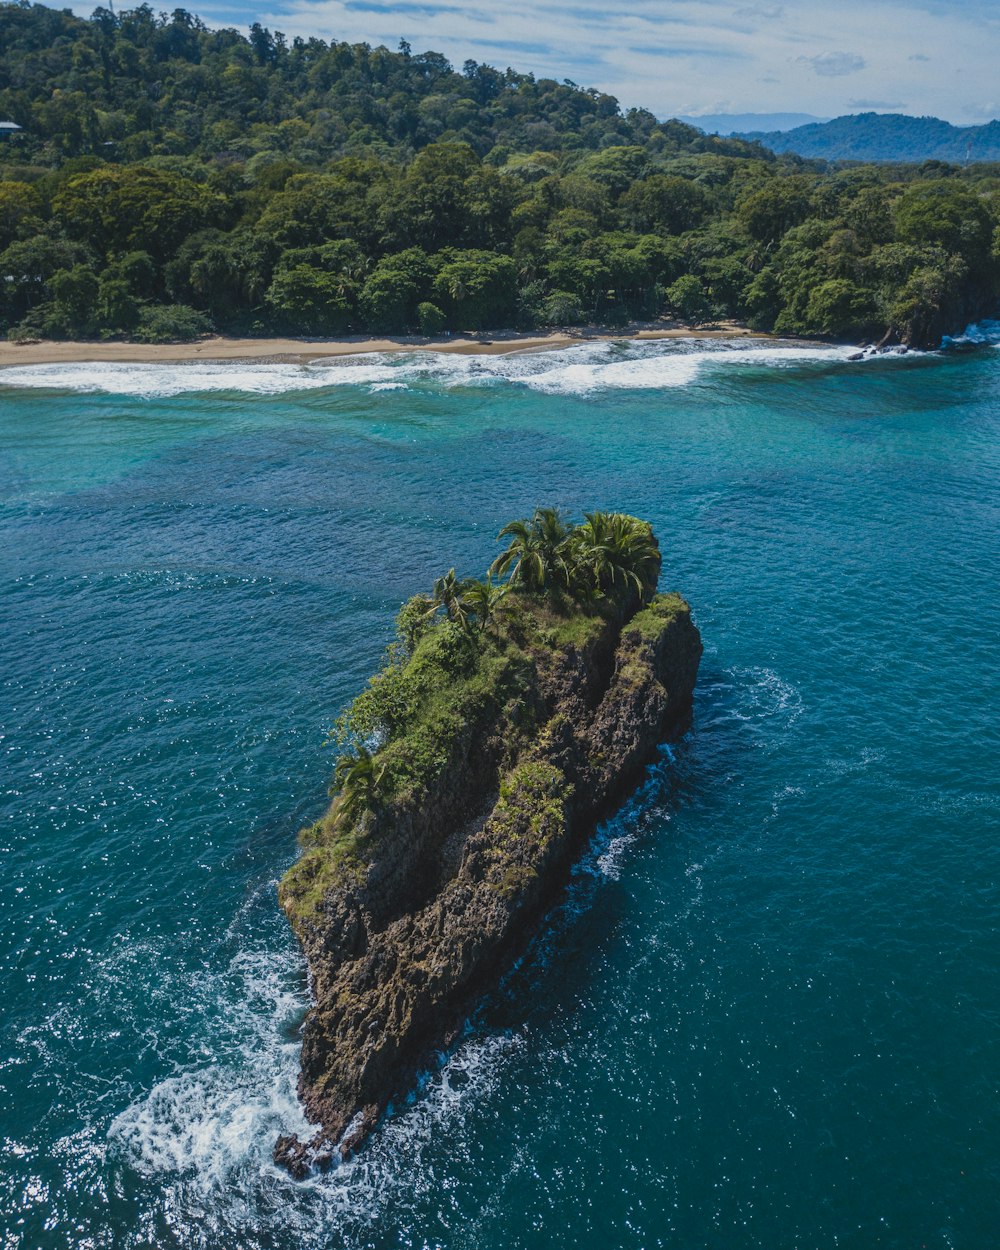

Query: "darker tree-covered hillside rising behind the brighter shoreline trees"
<box><xmin>0</xmin><ymin>3</ymin><xmax>753</xmax><ymax>173</ymax></box>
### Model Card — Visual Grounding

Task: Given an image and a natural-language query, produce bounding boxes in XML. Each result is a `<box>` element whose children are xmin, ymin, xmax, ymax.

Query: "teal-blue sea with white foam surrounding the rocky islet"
<box><xmin>0</xmin><ymin>328</ymin><xmax>1000</xmax><ymax>1250</ymax></box>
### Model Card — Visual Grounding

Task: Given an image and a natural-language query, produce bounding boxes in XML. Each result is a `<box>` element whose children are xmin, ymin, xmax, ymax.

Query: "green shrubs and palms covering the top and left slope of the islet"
<box><xmin>283</xmin><ymin>509</ymin><xmax>665</xmax><ymax>913</ymax></box>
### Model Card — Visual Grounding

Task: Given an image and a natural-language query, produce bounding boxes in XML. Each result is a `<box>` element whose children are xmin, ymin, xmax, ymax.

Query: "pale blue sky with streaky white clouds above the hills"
<box><xmin>107</xmin><ymin>0</ymin><xmax>1000</xmax><ymax>124</ymax></box>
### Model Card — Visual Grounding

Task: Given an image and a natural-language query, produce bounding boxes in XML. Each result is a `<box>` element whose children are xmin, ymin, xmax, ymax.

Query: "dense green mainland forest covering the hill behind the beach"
<box><xmin>0</xmin><ymin>3</ymin><xmax>1000</xmax><ymax>345</ymax></box>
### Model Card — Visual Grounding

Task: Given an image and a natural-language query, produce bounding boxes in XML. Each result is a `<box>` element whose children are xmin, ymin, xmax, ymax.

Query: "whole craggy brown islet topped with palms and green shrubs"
<box><xmin>274</xmin><ymin>509</ymin><xmax>701</xmax><ymax>1176</ymax></box>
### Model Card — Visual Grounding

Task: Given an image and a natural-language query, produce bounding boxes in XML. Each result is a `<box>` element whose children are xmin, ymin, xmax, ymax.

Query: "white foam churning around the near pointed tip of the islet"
<box><xmin>105</xmin><ymin>935</ymin><xmax>525</xmax><ymax>1250</ymax></box>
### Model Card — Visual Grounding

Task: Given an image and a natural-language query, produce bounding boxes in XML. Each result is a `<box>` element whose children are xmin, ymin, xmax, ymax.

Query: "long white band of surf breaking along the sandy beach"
<box><xmin>0</xmin><ymin>340</ymin><xmax>880</xmax><ymax>399</ymax></box>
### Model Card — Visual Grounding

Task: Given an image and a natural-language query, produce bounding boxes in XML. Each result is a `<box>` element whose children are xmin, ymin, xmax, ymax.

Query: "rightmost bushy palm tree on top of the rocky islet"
<box><xmin>569</xmin><ymin>513</ymin><xmax>660</xmax><ymax>600</ymax></box>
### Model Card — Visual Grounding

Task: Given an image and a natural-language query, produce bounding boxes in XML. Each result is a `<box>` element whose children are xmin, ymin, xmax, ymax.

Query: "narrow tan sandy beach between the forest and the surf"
<box><xmin>0</xmin><ymin>321</ymin><xmax>773</xmax><ymax>369</ymax></box>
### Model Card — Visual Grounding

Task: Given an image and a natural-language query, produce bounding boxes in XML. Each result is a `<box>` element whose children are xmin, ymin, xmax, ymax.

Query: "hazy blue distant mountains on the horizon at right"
<box><xmin>735</xmin><ymin>113</ymin><xmax>1000</xmax><ymax>164</ymax></box>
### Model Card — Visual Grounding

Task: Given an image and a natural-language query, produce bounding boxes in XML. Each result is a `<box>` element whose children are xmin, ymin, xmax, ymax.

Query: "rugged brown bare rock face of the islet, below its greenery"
<box><xmin>275</xmin><ymin>585</ymin><xmax>701</xmax><ymax>1175</ymax></box>
